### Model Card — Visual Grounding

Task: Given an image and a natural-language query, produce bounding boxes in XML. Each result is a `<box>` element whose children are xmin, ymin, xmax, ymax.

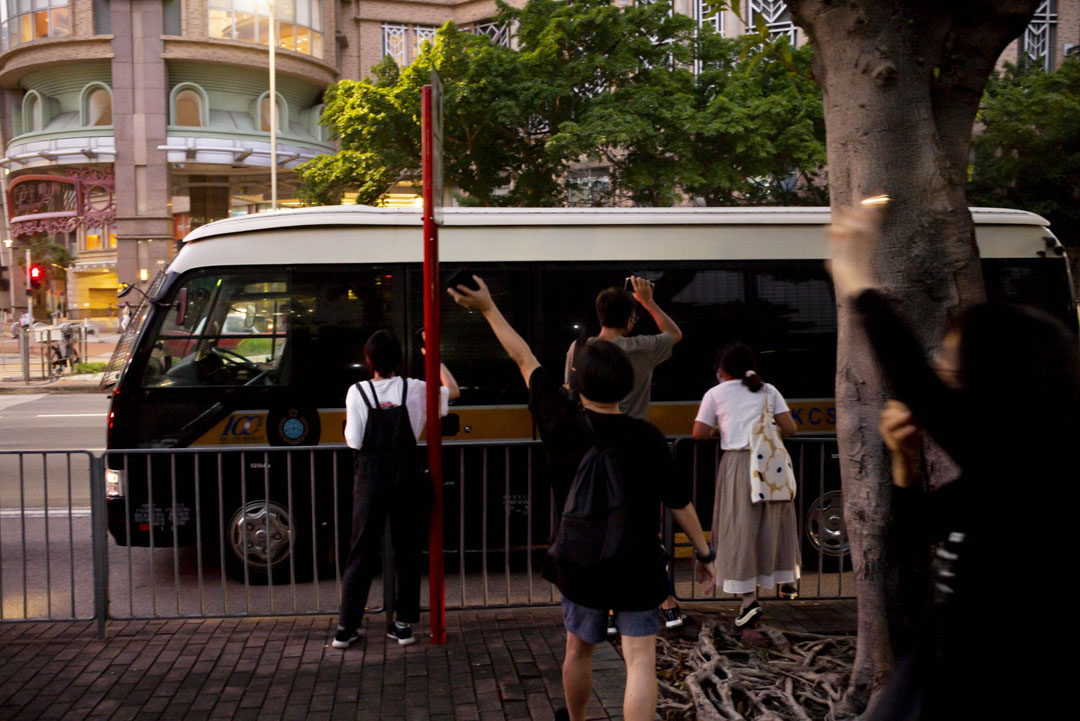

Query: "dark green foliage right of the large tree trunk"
<box><xmin>968</xmin><ymin>58</ymin><xmax>1080</xmax><ymax>247</ymax></box>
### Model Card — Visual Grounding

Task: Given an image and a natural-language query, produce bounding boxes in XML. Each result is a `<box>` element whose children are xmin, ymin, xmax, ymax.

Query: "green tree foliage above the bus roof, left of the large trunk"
<box><xmin>298</xmin><ymin>0</ymin><xmax>827</xmax><ymax>206</ymax></box>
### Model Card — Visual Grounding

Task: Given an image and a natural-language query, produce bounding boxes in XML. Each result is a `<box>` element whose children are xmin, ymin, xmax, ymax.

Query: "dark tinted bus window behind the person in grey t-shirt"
<box><xmin>538</xmin><ymin>263</ymin><xmax>747</xmax><ymax>402</ymax></box>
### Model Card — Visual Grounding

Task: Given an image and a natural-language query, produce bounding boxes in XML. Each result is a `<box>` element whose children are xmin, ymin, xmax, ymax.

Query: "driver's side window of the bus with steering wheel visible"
<box><xmin>143</xmin><ymin>274</ymin><xmax>291</xmax><ymax>387</ymax></box>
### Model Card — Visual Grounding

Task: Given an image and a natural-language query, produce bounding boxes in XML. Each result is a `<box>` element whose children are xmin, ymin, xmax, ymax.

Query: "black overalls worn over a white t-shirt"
<box><xmin>338</xmin><ymin>378</ymin><xmax>428</xmax><ymax>629</ymax></box>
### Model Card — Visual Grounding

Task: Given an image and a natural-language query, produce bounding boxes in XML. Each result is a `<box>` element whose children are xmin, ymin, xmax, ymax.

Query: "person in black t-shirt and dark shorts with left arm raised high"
<box><xmin>449</xmin><ymin>275</ymin><xmax>716</xmax><ymax>721</ymax></box>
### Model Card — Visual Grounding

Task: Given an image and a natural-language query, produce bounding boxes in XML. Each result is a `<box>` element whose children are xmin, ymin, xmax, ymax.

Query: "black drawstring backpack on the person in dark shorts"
<box><xmin>548</xmin><ymin>416</ymin><xmax>632</xmax><ymax>569</ymax></box>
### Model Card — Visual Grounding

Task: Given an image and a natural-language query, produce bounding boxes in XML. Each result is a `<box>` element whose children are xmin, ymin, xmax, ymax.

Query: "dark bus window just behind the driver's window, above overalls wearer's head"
<box><xmin>285</xmin><ymin>267</ymin><xmax>404</xmax><ymax>407</ymax></box>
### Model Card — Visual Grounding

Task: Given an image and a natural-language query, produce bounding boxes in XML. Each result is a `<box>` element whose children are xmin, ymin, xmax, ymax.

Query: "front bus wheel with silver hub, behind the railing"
<box><xmin>224</xmin><ymin>499</ymin><xmax>311</xmax><ymax>585</ymax></box>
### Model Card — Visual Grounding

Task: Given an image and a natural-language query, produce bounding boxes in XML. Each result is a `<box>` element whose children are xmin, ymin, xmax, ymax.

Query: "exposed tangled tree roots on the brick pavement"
<box><xmin>657</xmin><ymin>620</ymin><xmax>855</xmax><ymax>721</ymax></box>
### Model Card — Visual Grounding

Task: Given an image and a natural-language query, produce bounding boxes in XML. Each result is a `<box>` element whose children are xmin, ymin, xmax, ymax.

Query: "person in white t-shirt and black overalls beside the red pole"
<box><xmin>333</xmin><ymin>330</ymin><xmax>461</xmax><ymax>649</ymax></box>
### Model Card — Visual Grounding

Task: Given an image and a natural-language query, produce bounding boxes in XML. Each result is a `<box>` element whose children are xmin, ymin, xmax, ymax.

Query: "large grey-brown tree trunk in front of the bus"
<box><xmin>788</xmin><ymin>0</ymin><xmax>1038</xmax><ymax>710</ymax></box>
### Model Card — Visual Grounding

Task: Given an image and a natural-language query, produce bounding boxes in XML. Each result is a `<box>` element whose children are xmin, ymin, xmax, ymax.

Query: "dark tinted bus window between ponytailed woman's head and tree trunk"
<box><xmin>747</xmin><ymin>261</ymin><xmax>836</xmax><ymax>398</ymax></box>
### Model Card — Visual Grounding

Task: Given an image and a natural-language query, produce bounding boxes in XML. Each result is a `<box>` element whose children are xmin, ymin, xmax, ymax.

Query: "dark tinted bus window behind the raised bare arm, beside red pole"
<box><xmin>408</xmin><ymin>263</ymin><xmax>531</xmax><ymax>406</ymax></box>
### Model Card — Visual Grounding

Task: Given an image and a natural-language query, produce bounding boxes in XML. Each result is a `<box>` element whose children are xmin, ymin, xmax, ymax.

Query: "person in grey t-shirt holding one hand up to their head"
<box><xmin>563</xmin><ymin>276</ymin><xmax>683</xmax><ymax>421</ymax></box>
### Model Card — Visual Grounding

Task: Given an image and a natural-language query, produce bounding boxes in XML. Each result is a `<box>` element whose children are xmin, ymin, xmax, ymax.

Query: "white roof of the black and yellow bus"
<box><xmin>170</xmin><ymin>205</ymin><xmax>1053</xmax><ymax>273</ymax></box>
